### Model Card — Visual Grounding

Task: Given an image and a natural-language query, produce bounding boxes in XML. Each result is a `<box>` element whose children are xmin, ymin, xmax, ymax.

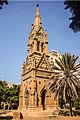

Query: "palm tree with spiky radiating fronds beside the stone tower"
<box><xmin>49</xmin><ymin>53</ymin><xmax>80</xmax><ymax>116</ymax></box>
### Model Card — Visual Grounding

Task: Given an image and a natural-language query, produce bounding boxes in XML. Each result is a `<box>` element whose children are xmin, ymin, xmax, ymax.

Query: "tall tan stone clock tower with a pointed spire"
<box><xmin>19</xmin><ymin>5</ymin><xmax>57</xmax><ymax>111</ymax></box>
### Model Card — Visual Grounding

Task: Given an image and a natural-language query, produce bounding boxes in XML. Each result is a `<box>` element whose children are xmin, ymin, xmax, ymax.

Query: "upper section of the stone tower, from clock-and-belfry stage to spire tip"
<box><xmin>28</xmin><ymin>5</ymin><xmax>48</xmax><ymax>56</ymax></box>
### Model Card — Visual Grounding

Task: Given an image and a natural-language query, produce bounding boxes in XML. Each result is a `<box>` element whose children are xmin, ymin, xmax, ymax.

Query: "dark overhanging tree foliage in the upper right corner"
<box><xmin>64</xmin><ymin>0</ymin><xmax>80</xmax><ymax>32</ymax></box>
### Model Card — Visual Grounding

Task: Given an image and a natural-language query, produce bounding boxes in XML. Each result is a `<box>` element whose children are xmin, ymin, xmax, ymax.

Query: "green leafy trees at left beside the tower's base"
<box><xmin>0</xmin><ymin>80</ymin><xmax>20</xmax><ymax>104</ymax></box>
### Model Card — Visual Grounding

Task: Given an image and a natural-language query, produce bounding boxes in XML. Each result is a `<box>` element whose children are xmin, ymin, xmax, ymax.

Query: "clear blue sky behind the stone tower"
<box><xmin>0</xmin><ymin>1</ymin><xmax>80</xmax><ymax>83</ymax></box>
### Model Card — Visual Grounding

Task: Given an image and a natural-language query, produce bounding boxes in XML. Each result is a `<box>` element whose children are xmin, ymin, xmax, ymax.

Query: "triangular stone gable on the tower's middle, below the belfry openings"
<box><xmin>36</xmin><ymin>53</ymin><xmax>51</xmax><ymax>70</ymax></box>
